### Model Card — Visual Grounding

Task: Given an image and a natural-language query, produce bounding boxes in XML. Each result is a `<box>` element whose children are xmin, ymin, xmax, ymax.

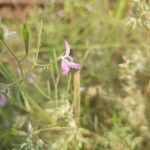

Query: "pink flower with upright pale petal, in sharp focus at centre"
<box><xmin>61</xmin><ymin>41</ymin><xmax>81</xmax><ymax>75</ymax></box>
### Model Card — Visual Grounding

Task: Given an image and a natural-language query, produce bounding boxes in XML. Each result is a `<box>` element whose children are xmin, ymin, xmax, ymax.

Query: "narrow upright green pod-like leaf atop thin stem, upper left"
<box><xmin>23</xmin><ymin>24</ymin><xmax>30</xmax><ymax>54</ymax></box>
